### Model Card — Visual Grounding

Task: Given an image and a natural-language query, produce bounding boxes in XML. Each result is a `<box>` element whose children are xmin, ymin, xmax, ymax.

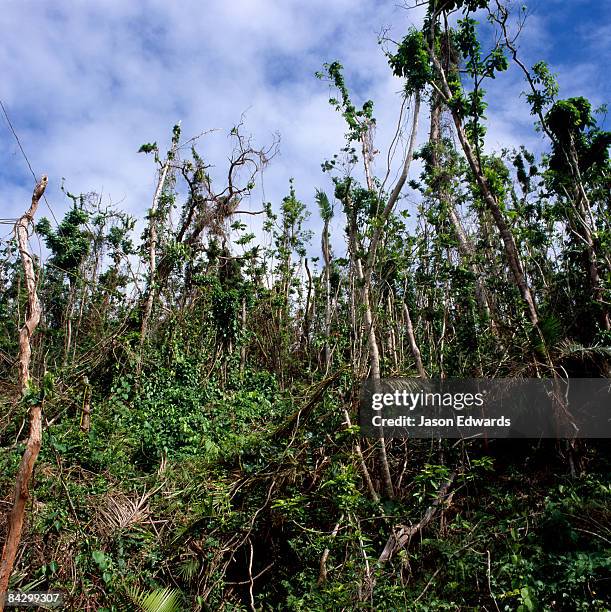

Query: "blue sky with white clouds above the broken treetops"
<box><xmin>0</xmin><ymin>0</ymin><xmax>611</xmax><ymax>258</ymax></box>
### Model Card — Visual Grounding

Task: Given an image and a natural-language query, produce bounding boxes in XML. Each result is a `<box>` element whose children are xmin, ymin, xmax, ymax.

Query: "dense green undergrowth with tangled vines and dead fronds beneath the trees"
<box><xmin>1</xmin><ymin>354</ymin><xmax>611</xmax><ymax>610</ymax></box>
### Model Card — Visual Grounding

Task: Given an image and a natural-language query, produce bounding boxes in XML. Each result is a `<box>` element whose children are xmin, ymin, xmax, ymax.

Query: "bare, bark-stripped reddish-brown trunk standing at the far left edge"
<box><xmin>0</xmin><ymin>176</ymin><xmax>47</xmax><ymax>612</ymax></box>
